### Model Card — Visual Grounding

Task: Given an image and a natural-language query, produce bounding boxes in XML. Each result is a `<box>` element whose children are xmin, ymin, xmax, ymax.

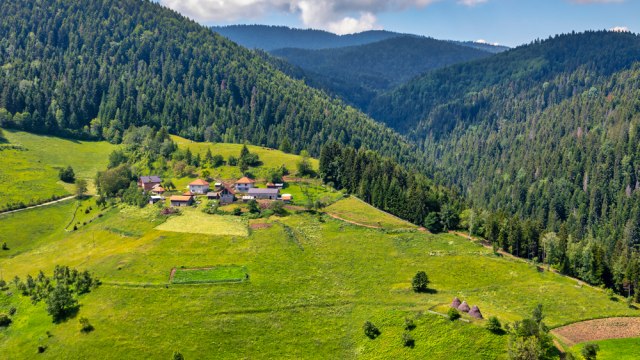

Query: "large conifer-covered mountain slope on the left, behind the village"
<box><xmin>0</xmin><ymin>0</ymin><xmax>415</xmax><ymax>163</ymax></box>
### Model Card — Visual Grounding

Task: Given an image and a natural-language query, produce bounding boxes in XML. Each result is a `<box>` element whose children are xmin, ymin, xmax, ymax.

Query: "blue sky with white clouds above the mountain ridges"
<box><xmin>158</xmin><ymin>0</ymin><xmax>640</xmax><ymax>46</ymax></box>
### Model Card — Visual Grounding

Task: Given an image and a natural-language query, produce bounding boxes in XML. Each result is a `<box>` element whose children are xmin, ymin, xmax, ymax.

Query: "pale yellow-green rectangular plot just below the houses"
<box><xmin>156</xmin><ymin>209</ymin><xmax>249</xmax><ymax>236</ymax></box>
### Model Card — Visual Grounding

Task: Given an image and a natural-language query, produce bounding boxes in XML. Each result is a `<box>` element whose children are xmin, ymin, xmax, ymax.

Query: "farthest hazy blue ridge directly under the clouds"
<box><xmin>211</xmin><ymin>25</ymin><xmax>403</xmax><ymax>51</ymax></box>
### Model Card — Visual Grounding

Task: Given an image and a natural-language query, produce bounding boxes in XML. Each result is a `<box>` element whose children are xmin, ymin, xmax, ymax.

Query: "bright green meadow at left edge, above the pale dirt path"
<box><xmin>0</xmin><ymin>130</ymin><xmax>115</xmax><ymax>210</ymax></box>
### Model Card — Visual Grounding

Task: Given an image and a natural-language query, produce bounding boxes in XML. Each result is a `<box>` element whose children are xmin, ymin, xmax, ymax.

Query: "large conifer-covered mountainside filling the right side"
<box><xmin>372</xmin><ymin>32</ymin><xmax>640</xmax><ymax>291</ymax></box>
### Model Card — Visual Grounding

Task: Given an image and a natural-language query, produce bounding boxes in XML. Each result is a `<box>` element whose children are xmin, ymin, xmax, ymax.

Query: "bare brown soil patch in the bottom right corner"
<box><xmin>551</xmin><ymin>317</ymin><xmax>640</xmax><ymax>346</ymax></box>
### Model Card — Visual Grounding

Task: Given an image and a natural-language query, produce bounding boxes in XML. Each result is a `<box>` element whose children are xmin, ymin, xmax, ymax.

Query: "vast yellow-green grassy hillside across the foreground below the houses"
<box><xmin>0</xmin><ymin>195</ymin><xmax>637</xmax><ymax>359</ymax></box>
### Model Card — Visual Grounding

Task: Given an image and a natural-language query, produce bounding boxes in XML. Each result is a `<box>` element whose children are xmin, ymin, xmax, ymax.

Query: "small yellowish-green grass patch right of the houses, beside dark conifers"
<box><xmin>324</xmin><ymin>196</ymin><xmax>417</xmax><ymax>229</ymax></box>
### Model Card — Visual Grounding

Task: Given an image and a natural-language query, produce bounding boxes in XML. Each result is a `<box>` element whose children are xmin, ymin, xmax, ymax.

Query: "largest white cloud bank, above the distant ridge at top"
<box><xmin>159</xmin><ymin>0</ymin><xmax>488</xmax><ymax>34</ymax></box>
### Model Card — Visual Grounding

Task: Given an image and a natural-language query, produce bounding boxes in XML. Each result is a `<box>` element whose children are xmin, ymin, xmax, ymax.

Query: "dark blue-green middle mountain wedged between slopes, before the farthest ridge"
<box><xmin>271</xmin><ymin>36</ymin><xmax>491</xmax><ymax>109</ymax></box>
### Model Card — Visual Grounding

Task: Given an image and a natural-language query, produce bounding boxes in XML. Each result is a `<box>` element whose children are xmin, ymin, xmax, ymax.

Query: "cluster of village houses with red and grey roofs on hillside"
<box><xmin>138</xmin><ymin>175</ymin><xmax>292</xmax><ymax>207</ymax></box>
